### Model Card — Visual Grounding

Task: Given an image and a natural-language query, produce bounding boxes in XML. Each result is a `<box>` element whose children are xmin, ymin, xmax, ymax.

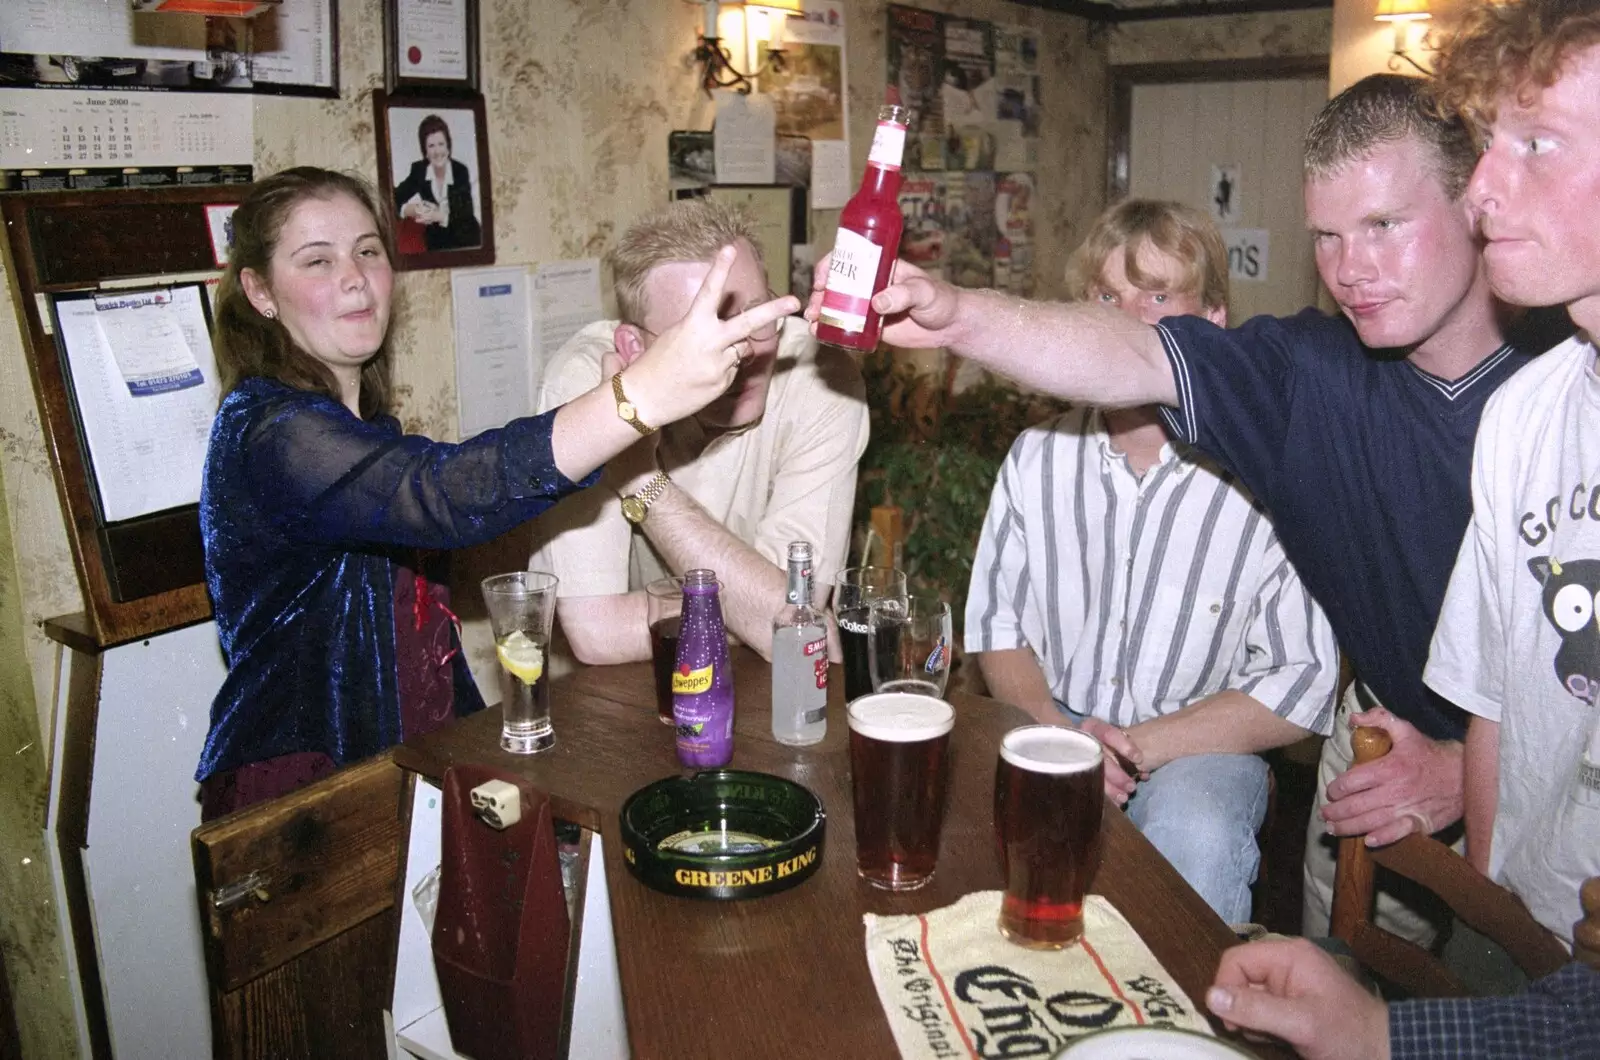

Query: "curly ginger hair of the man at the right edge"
<box><xmin>1434</xmin><ymin>0</ymin><xmax>1600</xmax><ymax>133</ymax></box>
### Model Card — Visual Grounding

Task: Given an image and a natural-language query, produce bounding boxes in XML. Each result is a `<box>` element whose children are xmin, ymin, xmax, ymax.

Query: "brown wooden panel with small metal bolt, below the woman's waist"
<box><xmin>190</xmin><ymin>754</ymin><xmax>408</xmax><ymax>1060</ymax></box>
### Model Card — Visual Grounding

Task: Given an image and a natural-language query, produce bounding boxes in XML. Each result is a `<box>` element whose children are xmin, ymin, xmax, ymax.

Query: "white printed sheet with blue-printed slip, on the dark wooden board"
<box><xmin>54</xmin><ymin>283</ymin><xmax>218</xmax><ymax>522</ymax></box>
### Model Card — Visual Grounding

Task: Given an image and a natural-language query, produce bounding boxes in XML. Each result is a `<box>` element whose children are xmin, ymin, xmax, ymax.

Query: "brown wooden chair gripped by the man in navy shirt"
<box><xmin>1330</xmin><ymin>727</ymin><xmax>1574</xmax><ymax>998</ymax></box>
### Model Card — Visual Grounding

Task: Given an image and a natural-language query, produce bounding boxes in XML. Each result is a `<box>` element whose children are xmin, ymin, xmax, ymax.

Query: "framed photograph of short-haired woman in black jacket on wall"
<box><xmin>373</xmin><ymin>91</ymin><xmax>494</xmax><ymax>269</ymax></box>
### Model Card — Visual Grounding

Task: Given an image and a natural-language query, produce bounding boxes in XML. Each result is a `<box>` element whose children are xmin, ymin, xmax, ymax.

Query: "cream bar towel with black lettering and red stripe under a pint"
<box><xmin>862</xmin><ymin>890</ymin><xmax>1211</xmax><ymax>1060</ymax></box>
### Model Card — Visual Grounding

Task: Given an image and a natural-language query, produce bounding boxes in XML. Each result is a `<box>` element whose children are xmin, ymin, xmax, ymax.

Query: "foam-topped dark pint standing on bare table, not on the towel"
<box><xmin>850</xmin><ymin>692</ymin><xmax>955</xmax><ymax>890</ymax></box>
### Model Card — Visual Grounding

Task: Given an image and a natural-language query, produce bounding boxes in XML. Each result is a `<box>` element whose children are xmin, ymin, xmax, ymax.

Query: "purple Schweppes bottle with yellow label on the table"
<box><xmin>672</xmin><ymin>570</ymin><xmax>733</xmax><ymax>769</ymax></box>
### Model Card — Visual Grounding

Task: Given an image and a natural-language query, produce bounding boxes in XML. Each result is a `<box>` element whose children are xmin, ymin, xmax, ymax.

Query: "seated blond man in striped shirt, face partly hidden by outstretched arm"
<box><xmin>966</xmin><ymin>200</ymin><xmax>1338</xmax><ymax>924</ymax></box>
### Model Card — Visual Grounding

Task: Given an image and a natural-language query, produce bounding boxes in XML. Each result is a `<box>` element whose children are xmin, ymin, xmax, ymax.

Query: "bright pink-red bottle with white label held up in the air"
<box><xmin>816</xmin><ymin>104</ymin><xmax>909</xmax><ymax>351</ymax></box>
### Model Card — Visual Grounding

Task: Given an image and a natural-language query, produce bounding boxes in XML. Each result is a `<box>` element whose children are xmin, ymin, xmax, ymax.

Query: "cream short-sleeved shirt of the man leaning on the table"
<box><xmin>530</xmin><ymin>317</ymin><xmax>869</xmax><ymax>611</ymax></box>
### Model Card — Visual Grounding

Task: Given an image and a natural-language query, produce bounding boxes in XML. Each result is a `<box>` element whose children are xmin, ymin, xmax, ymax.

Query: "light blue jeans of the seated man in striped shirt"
<box><xmin>1064</xmin><ymin>709</ymin><xmax>1267</xmax><ymax>924</ymax></box>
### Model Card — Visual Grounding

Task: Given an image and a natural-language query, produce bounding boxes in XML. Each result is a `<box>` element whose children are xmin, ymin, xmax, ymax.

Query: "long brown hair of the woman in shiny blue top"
<box><xmin>211</xmin><ymin>165</ymin><xmax>395</xmax><ymax>420</ymax></box>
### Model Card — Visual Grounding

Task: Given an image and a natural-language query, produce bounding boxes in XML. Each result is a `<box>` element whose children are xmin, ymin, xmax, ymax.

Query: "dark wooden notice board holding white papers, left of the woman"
<box><xmin>0</xmin><ymin>186</ymin><xmax>248</xmax><ymax>647</ymax></box>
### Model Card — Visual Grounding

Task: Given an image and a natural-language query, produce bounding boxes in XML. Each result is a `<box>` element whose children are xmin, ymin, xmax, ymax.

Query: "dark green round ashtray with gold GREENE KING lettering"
<box><xmin>622</xmin><ymin>769</ymin><xmax>827</xmax><ymax>901</ymax></box>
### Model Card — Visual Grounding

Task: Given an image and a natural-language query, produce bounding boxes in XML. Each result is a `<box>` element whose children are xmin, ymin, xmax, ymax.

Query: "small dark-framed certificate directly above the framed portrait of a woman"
<box><xmin>384</xmin><ymin>0</ymin><xmax>478</xmax><ymax>94</ymax></box>
